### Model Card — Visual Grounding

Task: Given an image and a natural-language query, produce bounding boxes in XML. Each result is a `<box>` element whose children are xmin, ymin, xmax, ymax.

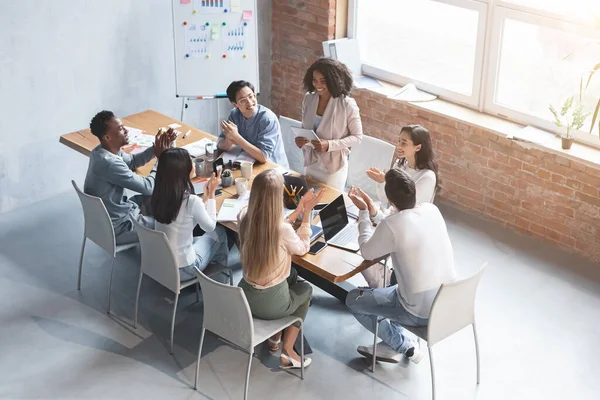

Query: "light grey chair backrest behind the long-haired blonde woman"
<box><xmin>195</xmin><ymin>268</ymin><xmax>254</xmax><ymax>351</ymax></box>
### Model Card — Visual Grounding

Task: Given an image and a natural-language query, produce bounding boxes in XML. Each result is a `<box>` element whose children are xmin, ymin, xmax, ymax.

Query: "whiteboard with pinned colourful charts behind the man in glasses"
<box><xmin>172</xmin><ymin>0</ymin><xmax>259</xmax><ymax>97</ymax></box>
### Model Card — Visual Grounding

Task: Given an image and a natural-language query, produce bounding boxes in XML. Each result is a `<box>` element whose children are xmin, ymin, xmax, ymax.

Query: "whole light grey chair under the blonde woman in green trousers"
<box><xmin>194</xmin><ymin>269</ymin><xmax>304</xmax><ymax>399</ymax></box>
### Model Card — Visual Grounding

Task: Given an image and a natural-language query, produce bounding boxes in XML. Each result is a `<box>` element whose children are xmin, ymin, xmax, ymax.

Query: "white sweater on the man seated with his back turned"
<box><xmin>358</xmin><ymin>203</ymin><xmax>456</xmax><ymax>318</ymax></box>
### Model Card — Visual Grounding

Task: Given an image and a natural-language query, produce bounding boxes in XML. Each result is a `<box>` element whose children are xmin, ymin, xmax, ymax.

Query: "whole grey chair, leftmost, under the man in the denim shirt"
<box><xmin>71</xmin><ymin>181</ymin><xmax>138</xmax><ymax>313</ymax></box>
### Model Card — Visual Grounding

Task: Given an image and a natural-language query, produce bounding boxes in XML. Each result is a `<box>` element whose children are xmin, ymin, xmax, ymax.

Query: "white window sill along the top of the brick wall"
<box><xmin>358</xmin><ymin>81</ymin><xmax>600</xmax><ymax>169</ymax></box>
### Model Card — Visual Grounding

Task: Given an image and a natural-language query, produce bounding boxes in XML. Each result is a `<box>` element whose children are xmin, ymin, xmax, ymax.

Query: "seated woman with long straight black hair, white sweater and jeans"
<box><xmin>151</xmin><ymin>148</ymin><xmax>228</xmax><ymax>281</ymax></box>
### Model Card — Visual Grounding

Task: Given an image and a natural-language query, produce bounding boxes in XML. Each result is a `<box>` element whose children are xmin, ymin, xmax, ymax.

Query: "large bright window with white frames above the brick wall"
<box><xmin>348</xmin><ymin>0</ymin><xmax>600</xmax><ymax>146</ymax></box>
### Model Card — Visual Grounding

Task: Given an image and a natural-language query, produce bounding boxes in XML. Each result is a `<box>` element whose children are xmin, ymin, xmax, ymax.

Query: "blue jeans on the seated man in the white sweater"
<box><xmin>346</xmin><ymin>285</ymin><xmax>428</xmax><ymax>354</ymax></box>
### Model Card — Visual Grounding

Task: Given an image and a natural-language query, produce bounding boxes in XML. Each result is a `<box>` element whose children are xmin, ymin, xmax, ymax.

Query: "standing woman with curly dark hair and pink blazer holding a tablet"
<box><xmin>296</xmin><ymin>58</ymin><xmax>363</xmax><ymax>190</ymax></box>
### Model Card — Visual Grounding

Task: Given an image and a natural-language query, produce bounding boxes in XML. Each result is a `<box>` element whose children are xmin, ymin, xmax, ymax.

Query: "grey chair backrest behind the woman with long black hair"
<box><xmin>131</xmin><ymin>218</ymin><xmax>180</xmax><ymax>293</ymax></box>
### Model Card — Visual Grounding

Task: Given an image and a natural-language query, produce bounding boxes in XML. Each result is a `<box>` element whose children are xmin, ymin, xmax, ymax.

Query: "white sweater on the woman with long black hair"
<box><xmin>155</xmin><ymin>195</ymin><xmax>217</xmax><ymax>268</ymax></box>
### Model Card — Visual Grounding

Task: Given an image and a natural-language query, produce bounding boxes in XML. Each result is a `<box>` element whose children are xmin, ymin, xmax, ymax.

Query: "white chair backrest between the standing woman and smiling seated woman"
<box><xmin>346</xmin><ymin>135</ymin><xmax>396</xmax><ymax>199</ymax></box>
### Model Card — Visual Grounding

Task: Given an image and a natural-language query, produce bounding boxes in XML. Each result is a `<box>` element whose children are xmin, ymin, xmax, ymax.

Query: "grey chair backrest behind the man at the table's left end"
<box><xmin>71</xmin><ymin>181</ymin><xmax>117</xmax><ymax>257</ymax></box>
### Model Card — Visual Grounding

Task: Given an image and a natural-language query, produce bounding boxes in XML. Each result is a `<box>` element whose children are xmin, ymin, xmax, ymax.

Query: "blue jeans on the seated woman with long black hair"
<box><xmin>179</xmin><ymin>225</ymin><xmax>229</xmax><ymax>282</ymax></box>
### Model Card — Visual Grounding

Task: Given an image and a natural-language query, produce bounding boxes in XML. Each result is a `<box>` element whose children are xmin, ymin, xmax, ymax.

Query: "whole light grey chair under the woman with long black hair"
<box><xmin>133</xmin><ymin>221</ymin><xmax>233</xmax><ymax>354</ymax></box>
